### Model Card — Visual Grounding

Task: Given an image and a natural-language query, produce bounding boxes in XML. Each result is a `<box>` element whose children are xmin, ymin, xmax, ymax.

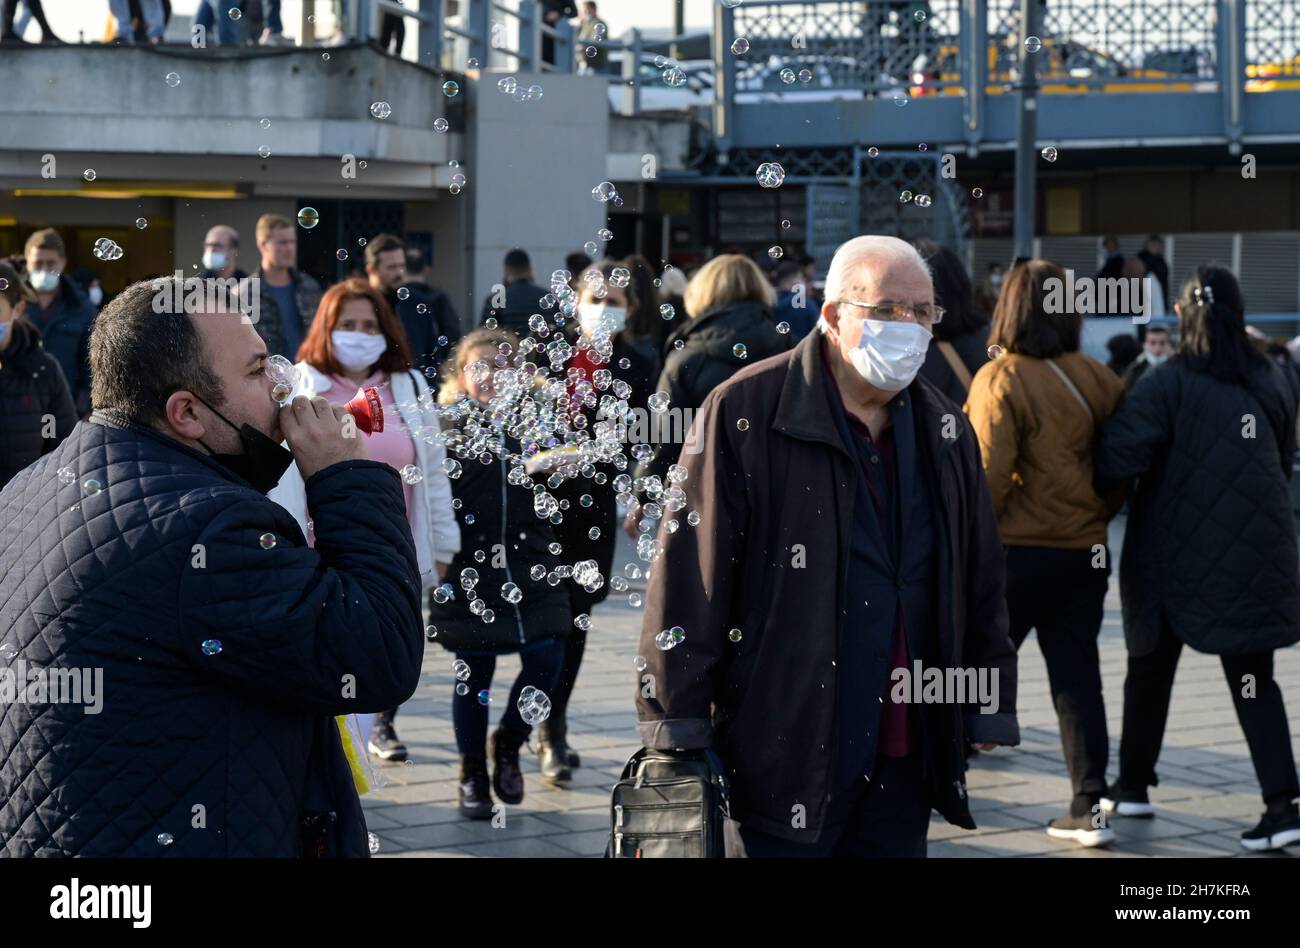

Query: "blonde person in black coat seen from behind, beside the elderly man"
<box><xmin>627</xmin><ymin>254</ymin><xmax>792</xmax><ymax>491</ymax></box>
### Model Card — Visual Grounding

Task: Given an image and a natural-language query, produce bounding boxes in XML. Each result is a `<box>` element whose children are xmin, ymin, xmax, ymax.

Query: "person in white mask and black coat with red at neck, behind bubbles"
<box><xmin>537</xmin><ymin>260</ymin><xmax>659</xmax><ymax>783</ymax></box>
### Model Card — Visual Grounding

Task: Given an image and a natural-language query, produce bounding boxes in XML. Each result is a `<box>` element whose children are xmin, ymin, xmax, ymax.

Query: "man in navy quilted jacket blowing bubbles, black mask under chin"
<box><xmin>0</xmin><ymin>278</ymin><xmax>423</xmax><ymax>857</ymax></box>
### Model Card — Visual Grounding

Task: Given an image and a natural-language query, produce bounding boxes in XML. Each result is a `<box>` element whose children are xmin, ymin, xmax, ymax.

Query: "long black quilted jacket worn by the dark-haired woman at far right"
<box><xmin>1095</xmin><ymin>356</ymin><xmax>1300</xmax><ymax>655</ymax></box>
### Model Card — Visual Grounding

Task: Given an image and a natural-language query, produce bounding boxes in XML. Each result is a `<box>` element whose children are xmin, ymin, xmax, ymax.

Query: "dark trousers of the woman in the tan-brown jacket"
<box><xmin>1006</xmin><ymin>546</ymin><xmax>1110</xmax><ymax>817</ymax></box>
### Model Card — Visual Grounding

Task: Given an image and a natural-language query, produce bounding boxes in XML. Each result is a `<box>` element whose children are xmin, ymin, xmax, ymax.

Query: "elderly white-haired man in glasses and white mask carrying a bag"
<box><xmin>637</xmin><ymin>237</ymin><xmax>1019</xmax><ymax>857</ymax></box>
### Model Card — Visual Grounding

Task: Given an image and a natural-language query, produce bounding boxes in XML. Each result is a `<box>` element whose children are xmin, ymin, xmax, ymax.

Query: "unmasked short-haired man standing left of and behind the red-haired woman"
<box><xmin>256</xmin><ymin>215</ymin><xmax>321</xmax><ymax>360</ymax></box>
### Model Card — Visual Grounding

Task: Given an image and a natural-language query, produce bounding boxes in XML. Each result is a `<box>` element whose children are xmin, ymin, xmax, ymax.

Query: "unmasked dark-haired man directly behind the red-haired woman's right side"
<box><xmin>365</xmin><ymin>234</ymin><xmax>460</xmax><ymax>373</ymax></box>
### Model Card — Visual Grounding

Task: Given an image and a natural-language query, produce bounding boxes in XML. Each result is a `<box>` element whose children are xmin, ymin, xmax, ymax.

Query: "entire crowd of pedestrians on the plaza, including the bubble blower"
<box><xmin>0</xmin><ymin>215</ymin><xmax>1300</xmax><ymax>856</ymax></box>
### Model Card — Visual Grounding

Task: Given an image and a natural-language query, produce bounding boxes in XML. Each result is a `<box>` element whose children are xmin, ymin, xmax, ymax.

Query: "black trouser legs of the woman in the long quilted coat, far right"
<box><xmin>1119</xmin><ymin>616</ymin><xmax>1300</xmax><ymax>808</ymax></box>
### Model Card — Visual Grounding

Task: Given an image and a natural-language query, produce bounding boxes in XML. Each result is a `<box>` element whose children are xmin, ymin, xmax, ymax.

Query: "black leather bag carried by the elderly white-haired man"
<box><xmin>605</xmin><ymin>748</ymin><xmax>731</xmax><ymax>860</ymax></box>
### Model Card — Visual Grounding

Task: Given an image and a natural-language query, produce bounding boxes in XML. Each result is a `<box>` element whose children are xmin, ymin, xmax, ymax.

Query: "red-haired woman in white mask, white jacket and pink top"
<box><xmin>270</xmin><ymin>280</ymin><xmax>460</xmax><ymax>761</ymax></box>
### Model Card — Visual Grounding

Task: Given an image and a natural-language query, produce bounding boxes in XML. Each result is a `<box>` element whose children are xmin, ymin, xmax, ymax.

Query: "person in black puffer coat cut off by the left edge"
<box><xmin>0</xmin><ymin>263</ymin><xmax>77</xmax><ymax>486</ymax></box>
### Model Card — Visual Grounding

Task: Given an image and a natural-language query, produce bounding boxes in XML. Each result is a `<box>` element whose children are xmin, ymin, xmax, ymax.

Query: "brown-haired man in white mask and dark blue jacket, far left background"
<box><xmin>23</xmin><ymin>228</ymin><xmax>95</xmax><ymax>415</ymax></box>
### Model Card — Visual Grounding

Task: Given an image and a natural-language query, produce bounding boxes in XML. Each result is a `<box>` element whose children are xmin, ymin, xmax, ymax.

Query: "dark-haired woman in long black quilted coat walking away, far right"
<box><xmin>1095</xmin><ymin>267</ymin><xmax>1300</xmax><ymax>849</ymax></box>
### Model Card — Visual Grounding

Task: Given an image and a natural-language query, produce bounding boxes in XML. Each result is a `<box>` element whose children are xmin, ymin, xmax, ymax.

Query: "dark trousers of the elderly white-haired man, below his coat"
<box><xmin>724</xmin><ymin>753</ymin><xmax>930</xmax><ymax>860</ymax></box>
